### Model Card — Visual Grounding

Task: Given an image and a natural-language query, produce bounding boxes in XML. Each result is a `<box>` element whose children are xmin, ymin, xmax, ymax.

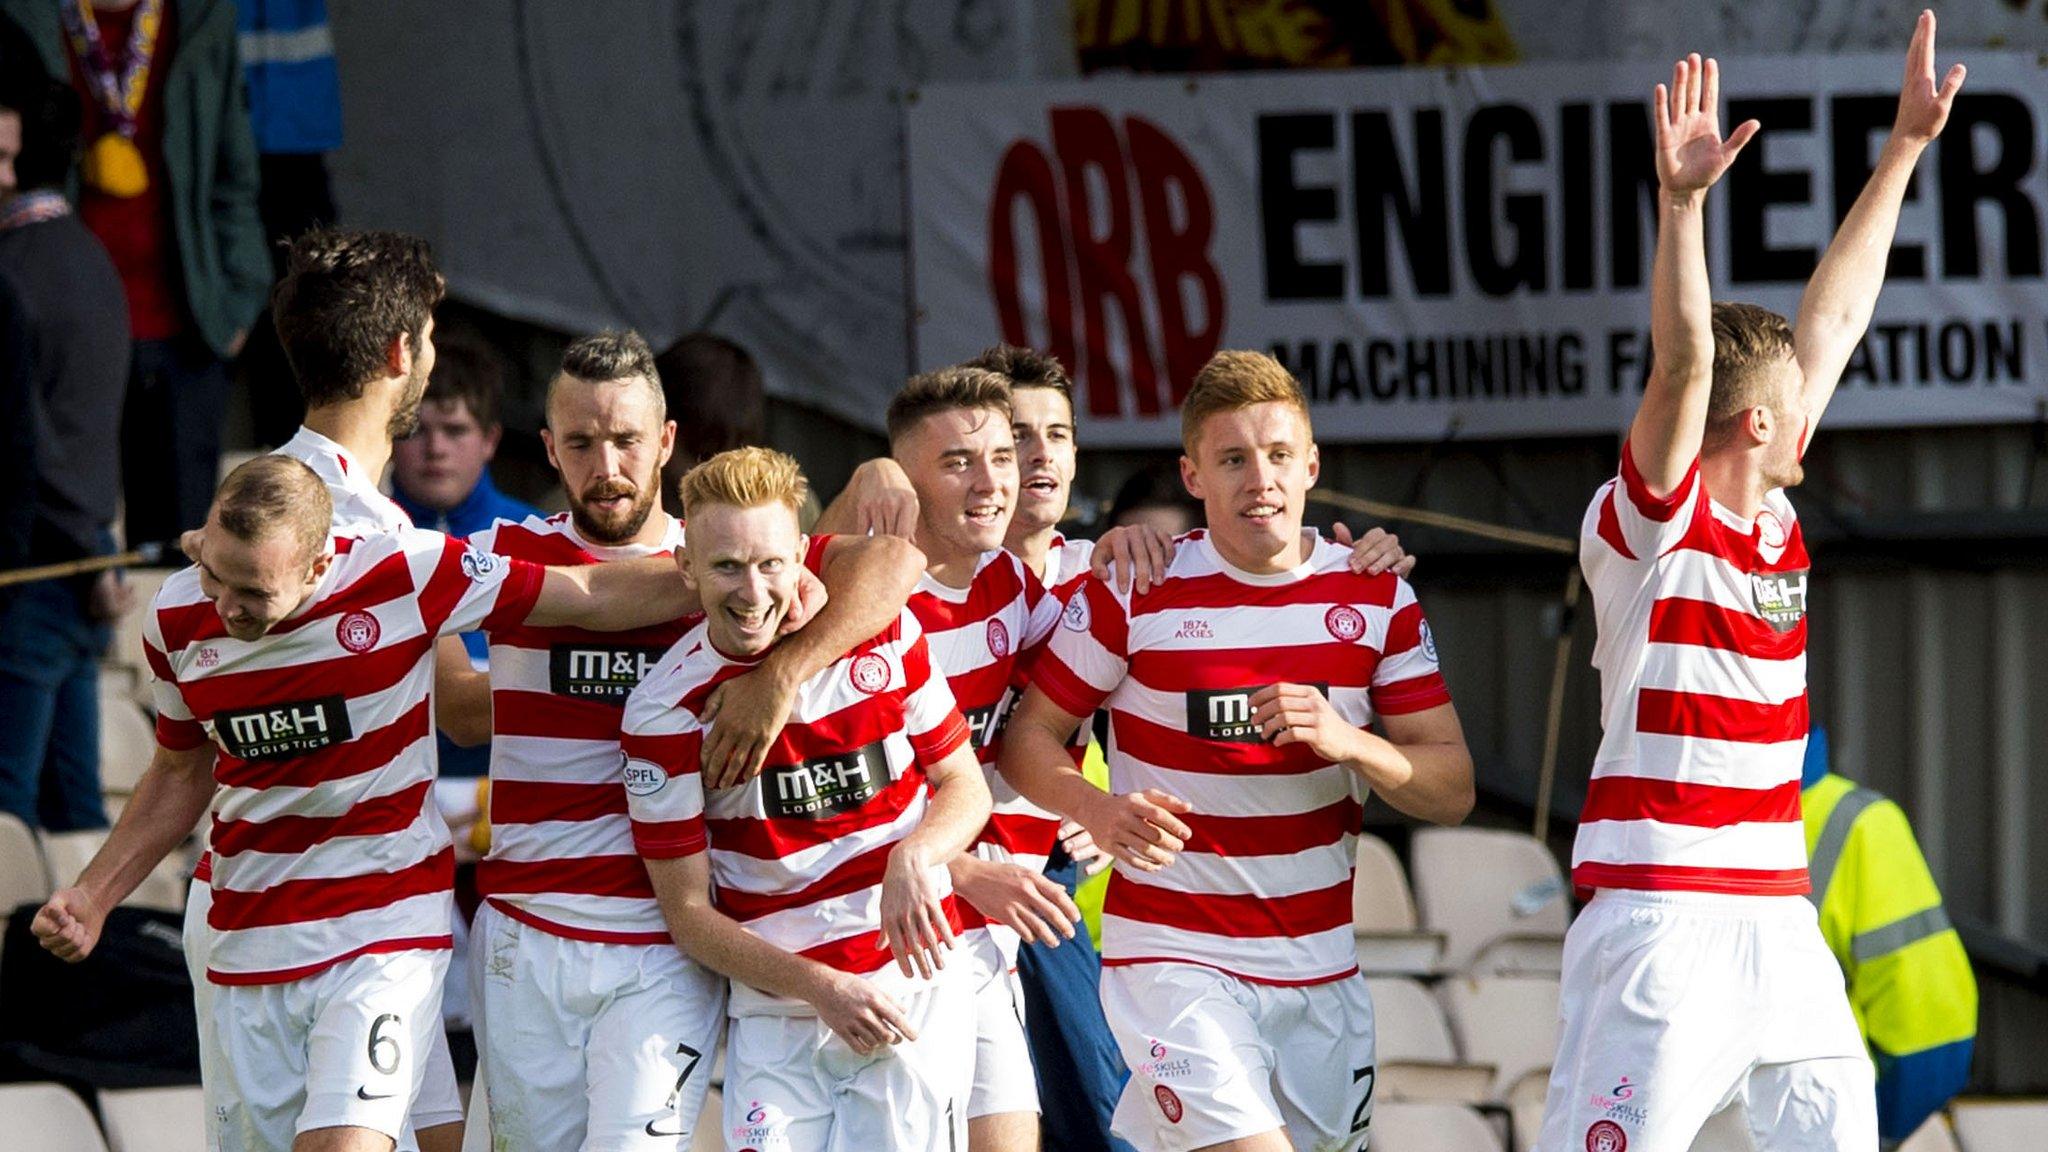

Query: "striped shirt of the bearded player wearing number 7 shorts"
<box><xmin>469</xmin><ymin>512</ymin><xmax>705</xmax><ymax>945</ymax></box>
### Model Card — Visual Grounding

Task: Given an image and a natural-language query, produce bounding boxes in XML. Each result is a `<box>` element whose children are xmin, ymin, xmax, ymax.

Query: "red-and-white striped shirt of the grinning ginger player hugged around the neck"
<box><xmin>623</xmin><ymin>611</ymin><xmax>967</xmax><ymax>1013</ymax></box>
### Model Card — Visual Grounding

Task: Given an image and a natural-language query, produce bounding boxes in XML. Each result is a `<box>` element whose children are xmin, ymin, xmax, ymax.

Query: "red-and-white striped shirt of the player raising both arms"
<box><xmin>1571</xmin><ymin>445</ymin><xmax>1808</xmax><ymax>896</ymax></box>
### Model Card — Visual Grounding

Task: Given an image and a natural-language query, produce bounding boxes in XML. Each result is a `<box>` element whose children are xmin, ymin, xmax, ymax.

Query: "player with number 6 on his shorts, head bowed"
<box><xmin>35</xmin><ymin>455</ymin><xmax>712</xmax><ymax>1152</ymax></box>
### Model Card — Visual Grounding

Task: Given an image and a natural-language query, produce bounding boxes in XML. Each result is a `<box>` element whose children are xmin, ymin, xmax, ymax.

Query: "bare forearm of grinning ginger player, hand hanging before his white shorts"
<box><xmin>647</xmin><ymin>853</ymin><xmax>918</xmax><ymax>1054</ymax></box>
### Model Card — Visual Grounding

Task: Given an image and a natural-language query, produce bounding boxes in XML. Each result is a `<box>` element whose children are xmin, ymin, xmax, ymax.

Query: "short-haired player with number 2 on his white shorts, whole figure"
<box><xmin>1001</xmin><ymin>353</ymin><xmax>1473</xmax><ymax>1152</ymax></box>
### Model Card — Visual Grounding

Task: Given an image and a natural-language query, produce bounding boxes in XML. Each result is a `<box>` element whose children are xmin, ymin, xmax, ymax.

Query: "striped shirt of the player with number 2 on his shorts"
<box><xmin>1032</xmin><ymin>531</ymin><xmax>1450</xmax><ymax>984</ymax></box>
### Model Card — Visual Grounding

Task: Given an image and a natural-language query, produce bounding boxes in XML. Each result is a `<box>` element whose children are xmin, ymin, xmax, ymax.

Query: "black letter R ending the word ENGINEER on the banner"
<box><xmin>1942</xmin><ymin>92</ymin><xmax>2042</xmax><ymax>277</ymax></box>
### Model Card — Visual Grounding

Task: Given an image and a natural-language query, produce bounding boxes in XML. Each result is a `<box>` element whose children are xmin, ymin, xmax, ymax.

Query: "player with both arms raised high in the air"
<box><xmin>1540</xmin><ymin>12</ymin><xmax>1964</xmax><ymax>1152</ymax></box>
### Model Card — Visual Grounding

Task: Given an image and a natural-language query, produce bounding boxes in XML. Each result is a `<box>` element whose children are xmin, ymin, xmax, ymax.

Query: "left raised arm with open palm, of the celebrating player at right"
<box><xmin>1628</xmin><ymin>53</ymin><xmax>1757</xmax><ymax>496</ymax></box>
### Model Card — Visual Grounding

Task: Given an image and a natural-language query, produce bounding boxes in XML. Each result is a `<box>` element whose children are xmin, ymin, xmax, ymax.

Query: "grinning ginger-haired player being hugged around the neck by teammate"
<box><xmin>623</xmin><ymin>449</ymin><xmax>989</xmax><ymax>1152</ymax></box>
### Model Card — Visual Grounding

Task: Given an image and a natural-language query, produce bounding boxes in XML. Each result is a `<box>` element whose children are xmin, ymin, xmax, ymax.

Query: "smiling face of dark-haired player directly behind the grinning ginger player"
<box><xmin>891</xmin><ymin>408</ymin><xmax>1018</xmax><ymax>564</ymax></box>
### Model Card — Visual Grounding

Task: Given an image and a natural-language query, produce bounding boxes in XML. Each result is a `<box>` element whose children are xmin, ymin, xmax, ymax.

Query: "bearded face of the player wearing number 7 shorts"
<box><xmin>541</xmin><ymin>375</ymin><xmax>694</xmax><ymax>545</ymax></box>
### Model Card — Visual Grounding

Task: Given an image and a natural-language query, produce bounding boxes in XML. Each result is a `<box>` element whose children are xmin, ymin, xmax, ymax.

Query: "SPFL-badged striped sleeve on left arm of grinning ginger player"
<box><xmin>618</xmin><ymin>689</ymin><xmax>709</xmax><ymax>861</ymax></box>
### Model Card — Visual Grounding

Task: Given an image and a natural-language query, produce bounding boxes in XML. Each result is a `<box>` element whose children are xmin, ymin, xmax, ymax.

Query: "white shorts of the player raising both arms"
<box><xmin>1536</xmin><ymin>890</ymin><xmax>1878</xmax><ymax>1152</ymax></box>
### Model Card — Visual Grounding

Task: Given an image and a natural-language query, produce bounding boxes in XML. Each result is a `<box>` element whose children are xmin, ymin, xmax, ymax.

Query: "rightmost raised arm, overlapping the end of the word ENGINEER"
<box><xmin>1792</xmin><ymin>10</ymin><xmax>1966</xmax><ymax>449</ymax></box>
